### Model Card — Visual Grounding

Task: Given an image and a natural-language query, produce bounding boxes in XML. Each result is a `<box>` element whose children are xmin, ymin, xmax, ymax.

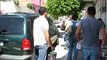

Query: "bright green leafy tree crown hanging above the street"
<box><xmin>47</xmin><ymin>0</ymin><xmax>83</xmax><ymax>16</ymax></box>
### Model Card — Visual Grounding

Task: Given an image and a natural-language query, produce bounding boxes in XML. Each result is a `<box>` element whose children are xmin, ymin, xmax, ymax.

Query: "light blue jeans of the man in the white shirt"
<box><xmin>37</xmin><ymin>44</ymin><xmax>48</xmax><ymax>60</ymax></box>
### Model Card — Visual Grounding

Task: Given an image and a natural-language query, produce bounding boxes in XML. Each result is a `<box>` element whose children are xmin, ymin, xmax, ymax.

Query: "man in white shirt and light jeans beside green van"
<box><xmin>33</xmin><ymin>7</ymin><xmax>54</xmax><ymax>60</ymax></box>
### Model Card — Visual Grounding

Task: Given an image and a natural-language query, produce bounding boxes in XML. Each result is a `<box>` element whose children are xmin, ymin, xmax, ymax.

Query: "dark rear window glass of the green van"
<box><xmin>0</xmin><ymin>17</ymin><xmax>24</xmax><ymax>34</ymax></box>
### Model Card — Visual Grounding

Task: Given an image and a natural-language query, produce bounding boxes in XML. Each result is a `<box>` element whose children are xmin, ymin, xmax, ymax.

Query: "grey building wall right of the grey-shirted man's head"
<box><xmin>94</xmin><ymin>0</ymin><xmax>107</xmax><ymax>30</ymax></box>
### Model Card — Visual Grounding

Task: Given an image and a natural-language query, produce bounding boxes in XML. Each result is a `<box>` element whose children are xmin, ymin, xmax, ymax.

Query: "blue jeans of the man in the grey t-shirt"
<box><xmin>83</xmin><ymin>48</ymin><xmax>99</xmax><ymax>60</ymax></box>
